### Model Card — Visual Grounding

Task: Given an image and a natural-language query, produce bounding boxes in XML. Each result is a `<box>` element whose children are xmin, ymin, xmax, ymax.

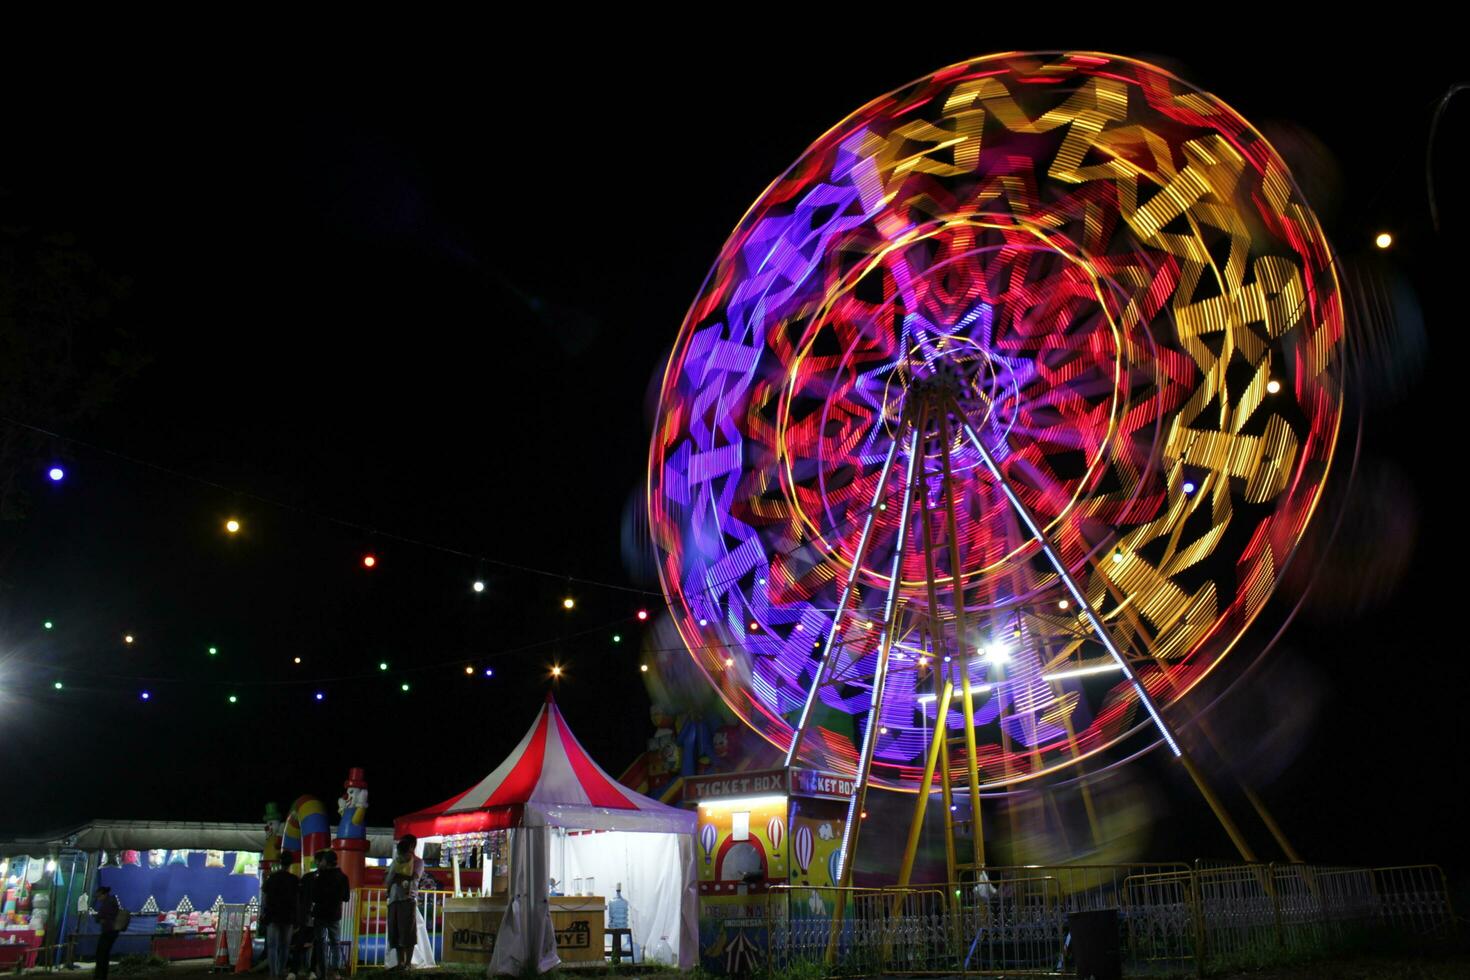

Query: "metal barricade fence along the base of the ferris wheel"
<box><xmin>766</xmin><ymin>862</ymin><xmax>1454</xmax><ymax>976</ymax></box>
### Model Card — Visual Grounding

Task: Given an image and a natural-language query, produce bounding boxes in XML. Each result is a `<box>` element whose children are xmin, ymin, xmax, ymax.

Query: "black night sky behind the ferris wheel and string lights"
<box><xmin>0</xmin><ymin>25</ymin><xmax>1470</xmax><ymax>867</ymax></box>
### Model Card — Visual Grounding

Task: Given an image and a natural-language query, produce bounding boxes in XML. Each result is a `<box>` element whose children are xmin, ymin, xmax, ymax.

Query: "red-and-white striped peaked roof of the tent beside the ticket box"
<box><xmin>392</xmin><ymin>695</ymin><xmax>697</xmax><ymax>837</ymax></box>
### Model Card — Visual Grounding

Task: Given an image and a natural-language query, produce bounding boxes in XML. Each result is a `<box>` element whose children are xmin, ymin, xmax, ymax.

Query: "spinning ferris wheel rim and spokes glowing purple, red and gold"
<box><xmin>648</xmin><ymin>53</ymin><xmax>1342</xmax><ymax>875</ymax></box>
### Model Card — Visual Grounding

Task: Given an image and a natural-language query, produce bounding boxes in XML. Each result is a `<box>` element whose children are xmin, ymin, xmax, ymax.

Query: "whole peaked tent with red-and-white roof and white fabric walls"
<box><xmin>394</xmin><ymin>695</ymin><xmax>700</xmax><ymax>976</ymax></box>
